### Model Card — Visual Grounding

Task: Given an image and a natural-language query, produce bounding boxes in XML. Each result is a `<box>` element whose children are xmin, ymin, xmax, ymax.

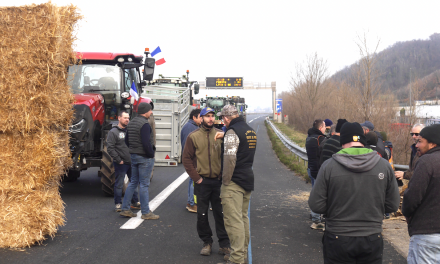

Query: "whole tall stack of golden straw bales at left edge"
<box><xmin>0</xmin><ymin>2</ymin><xmax>81</xmax><ymax>248</ymax></box>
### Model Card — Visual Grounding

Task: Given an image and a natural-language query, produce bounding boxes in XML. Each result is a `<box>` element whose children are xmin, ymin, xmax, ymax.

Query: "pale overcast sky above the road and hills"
<box><xmin>6</xmin><ymin>0</ymin><xmax>440</xmax><ymax>96</ymax></box>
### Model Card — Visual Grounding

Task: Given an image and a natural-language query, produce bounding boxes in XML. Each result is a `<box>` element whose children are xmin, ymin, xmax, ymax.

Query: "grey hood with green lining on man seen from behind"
<box><xmin>333</xmin><ymin>148</ymin><xmax>381</xmax><ymax>172</ymax></box>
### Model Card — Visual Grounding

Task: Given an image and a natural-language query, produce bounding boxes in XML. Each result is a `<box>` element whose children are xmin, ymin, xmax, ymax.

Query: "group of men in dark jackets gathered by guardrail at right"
<box><xmin>306</xmin><ymin>119</ymin><xmax>440</xmax><ymax>263</ymax></box>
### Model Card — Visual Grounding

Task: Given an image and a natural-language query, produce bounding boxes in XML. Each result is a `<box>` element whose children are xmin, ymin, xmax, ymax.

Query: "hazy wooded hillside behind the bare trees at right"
<box><xmin>331</xmin><ymin>33</ymin><xmax>440</xmax><ymax>102</ymax></box>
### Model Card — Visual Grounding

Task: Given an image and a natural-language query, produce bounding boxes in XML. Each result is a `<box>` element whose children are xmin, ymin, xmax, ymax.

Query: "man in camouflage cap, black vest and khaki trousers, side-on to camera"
<box><xmin>217</xmin><ymin>105</ymin><xmax>257</xmax><ymax>263</ymax></box>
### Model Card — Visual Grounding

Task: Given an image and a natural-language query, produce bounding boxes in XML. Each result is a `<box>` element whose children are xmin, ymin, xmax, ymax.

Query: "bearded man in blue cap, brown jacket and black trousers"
<box><xmin>181</xmin><ymin>107</ymin><xmax>230</xmax><ymax>256</ymax></box>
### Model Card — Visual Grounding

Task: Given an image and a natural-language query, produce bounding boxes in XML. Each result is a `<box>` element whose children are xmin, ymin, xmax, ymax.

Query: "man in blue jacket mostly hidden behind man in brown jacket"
<box><xmin>180</xmin><ymin>109</ymin><xmax>202</xmax><ymax>213</ymax></box>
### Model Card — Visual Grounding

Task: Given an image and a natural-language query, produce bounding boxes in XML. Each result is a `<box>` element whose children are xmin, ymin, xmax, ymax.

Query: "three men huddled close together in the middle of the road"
<box><xmin>181</xmin><ymin>105</ymin><xmax>257</xmax><ymax>263</ymax></box>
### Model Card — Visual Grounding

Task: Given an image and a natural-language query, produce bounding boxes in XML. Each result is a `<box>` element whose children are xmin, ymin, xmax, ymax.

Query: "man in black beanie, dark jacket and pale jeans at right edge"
<box><xmin>402</xmin><ymin>124</ymin><xmax>440</xmax><ymax>264</ymax></box>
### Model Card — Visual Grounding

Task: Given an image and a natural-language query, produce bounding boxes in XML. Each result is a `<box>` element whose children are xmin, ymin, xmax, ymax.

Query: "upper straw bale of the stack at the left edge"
<box><xmin>0</xmin><ymin>3</ymin><xmax>80</xmax><ymax>133</ymax></box>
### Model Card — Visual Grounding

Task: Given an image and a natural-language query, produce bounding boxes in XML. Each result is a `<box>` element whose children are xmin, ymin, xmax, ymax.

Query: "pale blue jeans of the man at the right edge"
<box><xmin>407</xmin><ymin>234</ymin><xmax>440</xmax><ymax>264</ymax></box>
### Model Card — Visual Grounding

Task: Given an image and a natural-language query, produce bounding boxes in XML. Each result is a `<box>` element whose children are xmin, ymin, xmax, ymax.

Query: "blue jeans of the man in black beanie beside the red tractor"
<box><xmin>122</xmin><ymin>154</ymin><xmax>154</xmax><ymax>214</ymax></box>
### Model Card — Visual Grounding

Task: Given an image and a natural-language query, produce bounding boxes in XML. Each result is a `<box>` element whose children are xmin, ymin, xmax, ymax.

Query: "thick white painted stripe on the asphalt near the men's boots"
<box><xmin>120</xmin><ymin>172</ymin><xmax>189</xmax><ymax>229</ymax></box>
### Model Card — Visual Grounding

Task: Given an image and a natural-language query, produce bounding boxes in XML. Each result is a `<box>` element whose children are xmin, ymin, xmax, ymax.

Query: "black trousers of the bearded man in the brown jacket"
<box><xmin>194</xmin><ymin>178</ymin><xmax>230</xmax><ymax>247</ymax></box>
